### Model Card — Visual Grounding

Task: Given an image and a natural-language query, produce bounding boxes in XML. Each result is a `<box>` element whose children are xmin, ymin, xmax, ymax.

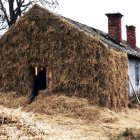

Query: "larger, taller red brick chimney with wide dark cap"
<box><xmin>106</xmin><ymin>13</ymin><xmax>123</xmax><ymax>43</ymax></box>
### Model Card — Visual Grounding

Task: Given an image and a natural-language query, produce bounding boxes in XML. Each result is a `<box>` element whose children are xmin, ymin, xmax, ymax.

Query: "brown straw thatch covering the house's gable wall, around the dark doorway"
<box><xmin>0</xmin><ymin>5</ymin><xmax>128</xmax><ymax>108</ymax></box>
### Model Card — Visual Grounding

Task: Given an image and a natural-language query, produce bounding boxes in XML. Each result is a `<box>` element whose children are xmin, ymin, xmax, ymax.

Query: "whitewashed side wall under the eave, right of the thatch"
<box><xmin>128</xmin><ymin>58</ymin><xmax>140</xmax><ymax>96</ymax></box>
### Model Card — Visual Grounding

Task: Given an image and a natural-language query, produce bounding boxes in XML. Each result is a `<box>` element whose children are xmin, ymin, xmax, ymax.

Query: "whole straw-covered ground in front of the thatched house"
<box><xmin>0</xmin><ymin>93</ymin><xmax>140</xmax><ymax>140</ymax></box>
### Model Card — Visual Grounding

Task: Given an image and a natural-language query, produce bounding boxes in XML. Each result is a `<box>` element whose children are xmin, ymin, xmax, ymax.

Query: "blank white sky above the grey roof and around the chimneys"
<box><xmin>58</xmin><ymin>0</ymin><xmax>140</xmax><ymax>47</ymax></box>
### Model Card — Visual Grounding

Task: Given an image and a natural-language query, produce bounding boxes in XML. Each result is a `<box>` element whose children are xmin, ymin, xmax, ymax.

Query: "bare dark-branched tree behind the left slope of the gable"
<box><xmin>0</xmin><ymin>0</ymin><xmax>59</xmax><ymax>31</ymax></box>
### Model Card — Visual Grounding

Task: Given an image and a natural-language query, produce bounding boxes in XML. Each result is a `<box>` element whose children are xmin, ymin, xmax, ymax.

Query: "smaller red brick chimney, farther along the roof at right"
<box><xmin>126</xmin><ymin>25</ymin><xmax>136</xmax><ymax>49</ymax></box>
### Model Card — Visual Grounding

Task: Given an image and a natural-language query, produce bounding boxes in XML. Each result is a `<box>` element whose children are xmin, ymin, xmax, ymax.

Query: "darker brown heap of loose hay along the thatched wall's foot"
<box><xmin>0</xmin><ymin>93</ymin><xmax>100</xmax><ymax>121</ymax></box>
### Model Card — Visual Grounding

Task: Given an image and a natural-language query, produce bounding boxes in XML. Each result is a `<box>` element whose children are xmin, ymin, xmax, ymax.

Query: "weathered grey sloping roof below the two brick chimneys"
<box><xmin>58</xmin><ymin>16</ymin><xmax>140</xmax><ymax>58</ymax></box>
